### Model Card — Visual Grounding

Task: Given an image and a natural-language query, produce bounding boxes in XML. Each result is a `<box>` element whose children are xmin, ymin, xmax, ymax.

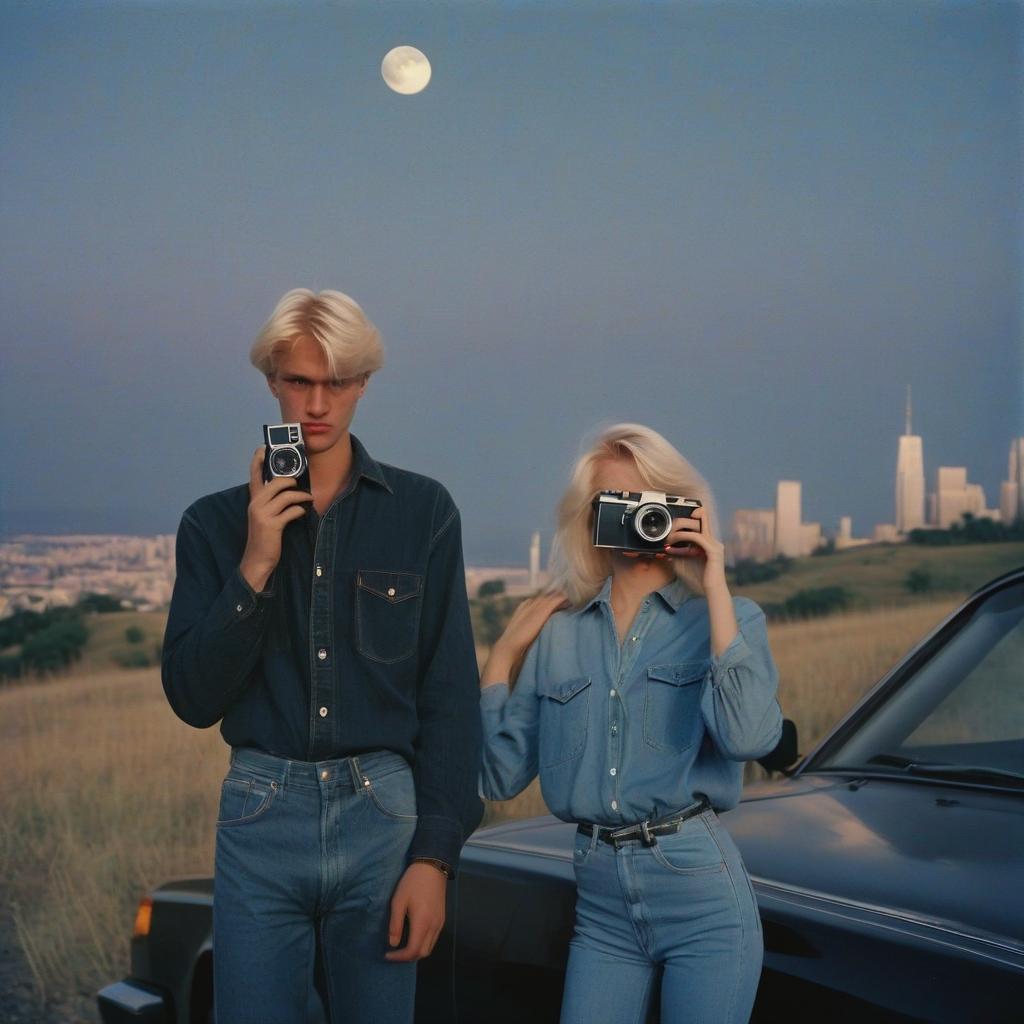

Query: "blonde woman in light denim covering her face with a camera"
<box><xmin>480</xmin><ymin>424</ymin><xmax>782</xmax><ymax>1024</ymax></box>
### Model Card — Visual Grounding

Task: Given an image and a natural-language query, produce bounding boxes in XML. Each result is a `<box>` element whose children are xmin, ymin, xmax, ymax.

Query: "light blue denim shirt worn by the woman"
<box><xmin>480</xmin><ymin>577</ymin><xmax>782</xmax><ymax>826</ymax></box>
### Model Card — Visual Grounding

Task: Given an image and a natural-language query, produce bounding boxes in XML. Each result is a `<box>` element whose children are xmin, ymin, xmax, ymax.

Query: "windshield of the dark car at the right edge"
<box><xmin>810</xmin><ymin>583</ymin><xmax>1024</xmax><ymax>787</ymax></box>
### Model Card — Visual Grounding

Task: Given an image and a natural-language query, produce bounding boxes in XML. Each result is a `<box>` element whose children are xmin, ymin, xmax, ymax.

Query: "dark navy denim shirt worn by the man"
<box><xmin>163</xmin><ymin>436</ymin><xmax>482</xmax><ymax>866</ymax></box>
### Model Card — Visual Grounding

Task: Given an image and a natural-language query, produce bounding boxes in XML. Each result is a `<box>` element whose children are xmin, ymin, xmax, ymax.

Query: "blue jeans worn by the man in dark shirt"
<box><xmin>213</xmin><ymin>748</ymin><xmax>416</xmax><ymax>1024</ymax></box>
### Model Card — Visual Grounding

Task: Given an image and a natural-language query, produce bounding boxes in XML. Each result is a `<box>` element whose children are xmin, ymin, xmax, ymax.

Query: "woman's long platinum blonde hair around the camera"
<box><xmin>549</xmin><ymin>423</ymin><xmax>718</xmax><ymax>606</ymax></box>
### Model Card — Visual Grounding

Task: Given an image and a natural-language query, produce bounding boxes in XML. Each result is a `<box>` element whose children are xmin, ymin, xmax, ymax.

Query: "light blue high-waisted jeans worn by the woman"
<box><xmin>561</xmin><ymin>810</ymin><xmax>764</xmax><ymax>1024</ymax></box>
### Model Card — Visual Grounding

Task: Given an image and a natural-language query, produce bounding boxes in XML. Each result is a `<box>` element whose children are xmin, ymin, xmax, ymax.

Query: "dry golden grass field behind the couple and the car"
<box><xmin>0</xmin><ymin>598</ymin><xmax>957</xmax><ymax>1020</ymax></box>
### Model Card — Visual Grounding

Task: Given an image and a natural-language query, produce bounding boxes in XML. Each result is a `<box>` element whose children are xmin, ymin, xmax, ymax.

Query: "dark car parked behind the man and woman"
<box><xmin>99</xmin><ymin>568</ymin><xmax>1024</xmax><ymax>1024</ymax></box>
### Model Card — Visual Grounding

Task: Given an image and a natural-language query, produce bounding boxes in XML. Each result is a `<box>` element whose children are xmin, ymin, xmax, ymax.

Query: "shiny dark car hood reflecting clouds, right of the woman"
<box><xmin>722</xmin><ymin>775</ymin><xmax>1024</xmax><ymax>941</ymax></box>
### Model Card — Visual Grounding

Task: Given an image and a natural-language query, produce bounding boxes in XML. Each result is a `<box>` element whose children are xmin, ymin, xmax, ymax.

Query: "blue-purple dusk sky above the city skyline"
<box><xmin>0</xmin><ymin>0</ymin><xmax>1024</xmax><ymax>564</ymax></box>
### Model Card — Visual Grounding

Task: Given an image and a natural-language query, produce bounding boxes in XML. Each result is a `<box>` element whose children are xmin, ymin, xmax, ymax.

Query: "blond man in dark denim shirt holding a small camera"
<box><xmin>163</xmin><ymin>289</ymin><xmax>481</xmax><ymax>1024</ymax></box>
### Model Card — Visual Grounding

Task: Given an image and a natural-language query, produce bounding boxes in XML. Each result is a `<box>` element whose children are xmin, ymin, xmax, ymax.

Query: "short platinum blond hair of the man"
<box><xmin>249</xmin><ymin>288</ymin><xmax>384</xmax><ymax>378</ymax></box>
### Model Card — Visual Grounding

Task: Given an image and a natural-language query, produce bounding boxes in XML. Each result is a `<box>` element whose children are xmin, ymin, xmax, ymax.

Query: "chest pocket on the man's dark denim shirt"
<box><xmin>355</xmin><ymin>569</ymin><xmax>423</xmax><ymax>665</ymax></box>
